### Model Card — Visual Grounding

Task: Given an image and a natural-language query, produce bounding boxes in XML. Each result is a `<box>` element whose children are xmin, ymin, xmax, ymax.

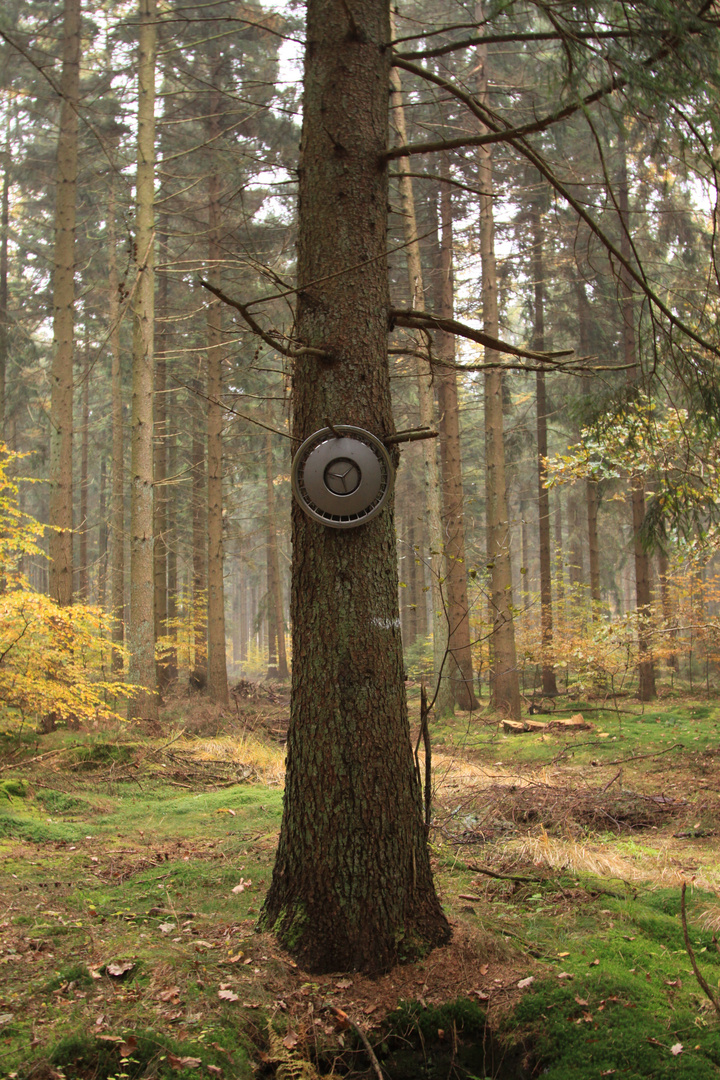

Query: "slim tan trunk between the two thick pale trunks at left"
<box><xmin>108</xmin><ymin>143</ymin><xmax>125</xmax><ymax>674</ymax></box>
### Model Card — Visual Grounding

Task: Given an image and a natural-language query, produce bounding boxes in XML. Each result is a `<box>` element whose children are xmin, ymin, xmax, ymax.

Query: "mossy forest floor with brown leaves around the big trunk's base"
<box><xmin>0</xmin><ymin>683</ymin><xmax>720</xmax><ymax>1080</ymax></box>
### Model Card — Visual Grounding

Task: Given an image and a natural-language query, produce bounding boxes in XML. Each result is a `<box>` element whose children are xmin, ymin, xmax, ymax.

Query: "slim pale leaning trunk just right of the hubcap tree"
<box><xmin>391</xmin><ymin>56</ymin><xmax>454</xmax><ymax>716</ymax></box>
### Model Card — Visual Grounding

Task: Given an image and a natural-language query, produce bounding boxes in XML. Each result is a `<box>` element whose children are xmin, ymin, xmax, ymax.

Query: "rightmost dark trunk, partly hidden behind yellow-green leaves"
<box><xmin>617</xmin><ymin>132</ymin><xmax>655</xmax><ymax>701</ymax></box>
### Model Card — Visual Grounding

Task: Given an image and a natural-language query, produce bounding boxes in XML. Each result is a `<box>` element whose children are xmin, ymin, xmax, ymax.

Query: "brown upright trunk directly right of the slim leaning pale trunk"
<box><xmin>436</xmin><ymin>153</ymin><xmax>478</xmax><ymax>710</ymax></box>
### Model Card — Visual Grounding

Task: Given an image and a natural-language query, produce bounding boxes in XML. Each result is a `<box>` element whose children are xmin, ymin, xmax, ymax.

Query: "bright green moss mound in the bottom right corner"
<box><xmin>503</xmin><ymin>880</ymin><xmax>720</xmax><ymax>1080</ymax></box>
